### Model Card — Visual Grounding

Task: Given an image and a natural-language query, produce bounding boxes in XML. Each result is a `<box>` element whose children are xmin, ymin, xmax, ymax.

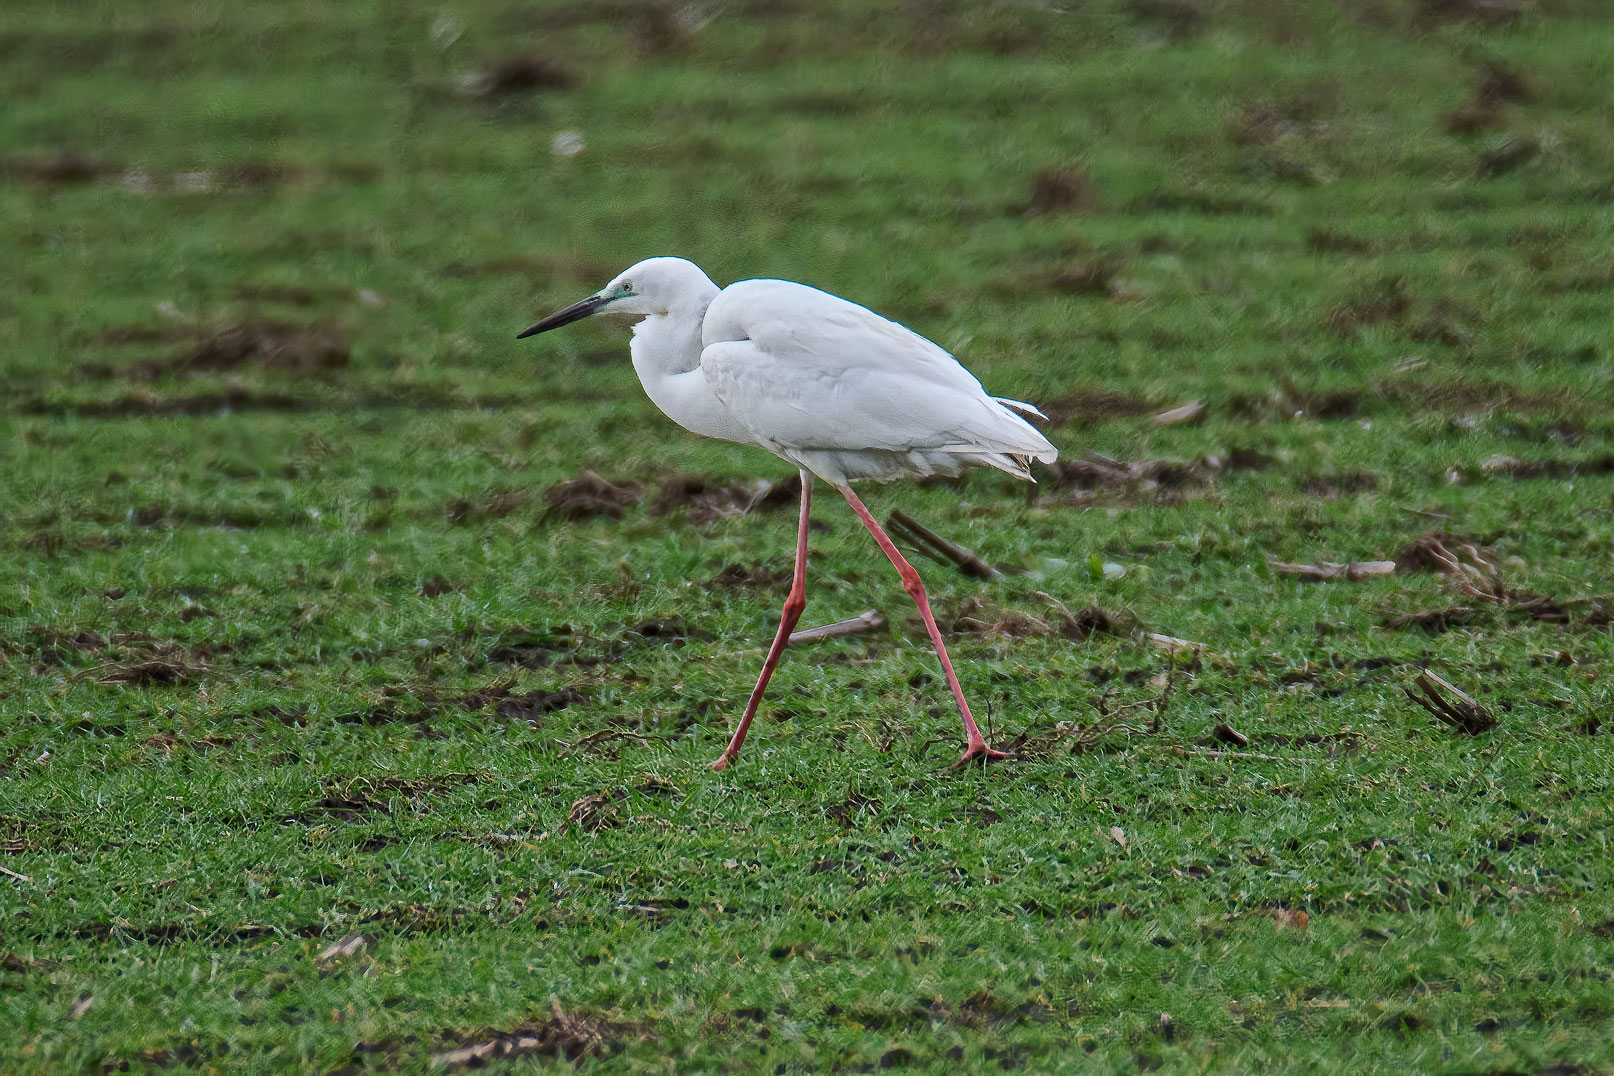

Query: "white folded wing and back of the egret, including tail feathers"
<box><xmin>700</xmin><ymin>281</ymin><xmax>1057</xmax><ymax>481</ymax></box>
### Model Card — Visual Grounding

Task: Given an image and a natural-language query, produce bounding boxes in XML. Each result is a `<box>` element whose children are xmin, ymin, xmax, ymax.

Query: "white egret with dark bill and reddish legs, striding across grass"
<box><xmin>518</xmin><ymin>258</ymin><xmax>1059</xmax><ymax>769</ymax></box>
